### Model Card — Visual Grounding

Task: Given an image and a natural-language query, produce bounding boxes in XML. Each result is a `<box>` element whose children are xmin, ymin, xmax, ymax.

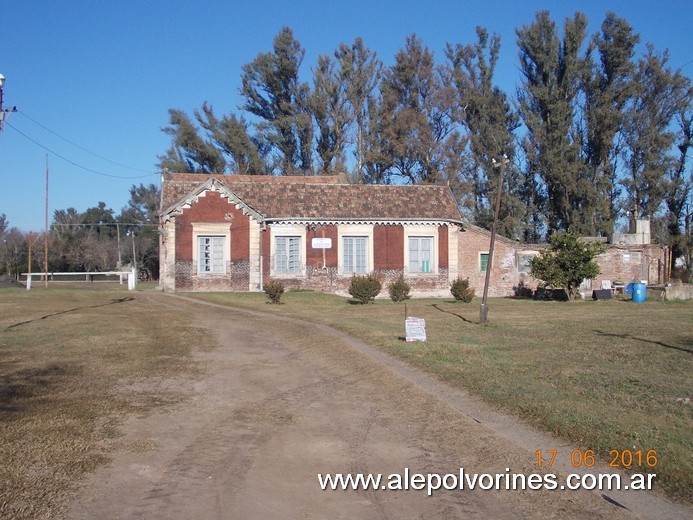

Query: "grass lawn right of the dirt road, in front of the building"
<box><xmin>195</xmin><ymin>292</ymin><xmax>693</xmax><ymax>503</ymax></box>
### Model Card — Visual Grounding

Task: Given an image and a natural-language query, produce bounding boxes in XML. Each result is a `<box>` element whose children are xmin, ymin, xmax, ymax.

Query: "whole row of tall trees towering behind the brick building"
<box><xmin>159</xmin><ymin>15</ymin><xmax>693</xmax><ymax>276</ymax></box>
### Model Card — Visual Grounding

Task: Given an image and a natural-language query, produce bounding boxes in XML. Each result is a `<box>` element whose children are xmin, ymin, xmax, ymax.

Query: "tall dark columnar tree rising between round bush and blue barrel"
<box><xmin>579</xmin><ymin>13</ymin><xmax>639</xmax><ymax>236</ymax></box>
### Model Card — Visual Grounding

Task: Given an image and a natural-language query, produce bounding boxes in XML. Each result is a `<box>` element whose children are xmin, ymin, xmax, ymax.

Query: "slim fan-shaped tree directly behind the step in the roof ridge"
<box><xmin>335</xmin><ymin>37</ymin><xmax>383</xmax><ymax>182</ymax></box>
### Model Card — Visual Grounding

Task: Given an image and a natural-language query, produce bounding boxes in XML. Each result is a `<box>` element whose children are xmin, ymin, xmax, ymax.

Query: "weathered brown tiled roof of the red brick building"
<box><xmin>162</xmin><ymin>174</ymin><xmax>461</xmax><ymax>222</ymax></box>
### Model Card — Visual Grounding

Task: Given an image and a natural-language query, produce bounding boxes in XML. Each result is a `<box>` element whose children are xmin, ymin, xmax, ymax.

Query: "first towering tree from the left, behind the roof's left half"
<box><xmin>241</xmin><ymin>27</ymin><xmax>313</xmax><ymax>175</ymax></box>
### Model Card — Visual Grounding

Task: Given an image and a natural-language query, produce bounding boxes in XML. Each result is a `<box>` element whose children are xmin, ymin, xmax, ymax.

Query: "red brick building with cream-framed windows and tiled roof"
<box><xmin>160</xmin><ymin>173</ymin><xmax>667</xmax><ymax>296</ymax></box>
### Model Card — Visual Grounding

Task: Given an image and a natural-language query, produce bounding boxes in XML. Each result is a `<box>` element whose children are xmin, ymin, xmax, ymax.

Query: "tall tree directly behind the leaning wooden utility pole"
<box><xmin>446</xmin><ymin>27</ymin><xmax>523</xmax><ymax>237</ymax></box>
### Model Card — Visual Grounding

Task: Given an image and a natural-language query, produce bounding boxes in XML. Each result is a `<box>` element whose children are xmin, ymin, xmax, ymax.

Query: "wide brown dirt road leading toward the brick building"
<box><xmin>68</xmin><ymin>293</ymin><xmax>691</xmax><ymax>520</ymax></box>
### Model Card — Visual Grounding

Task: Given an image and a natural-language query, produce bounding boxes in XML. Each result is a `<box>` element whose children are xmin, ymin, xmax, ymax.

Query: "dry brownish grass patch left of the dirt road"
<box><xmin>0</xmin><ymin>287</ymin><xmax>212</xmax><ymax>519</ymax></box>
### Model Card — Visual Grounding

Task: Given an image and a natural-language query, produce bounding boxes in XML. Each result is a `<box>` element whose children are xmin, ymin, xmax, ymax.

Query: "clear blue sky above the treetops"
<box><xmin>0</xmin><ymin>0</ymin><xmax>693</xmax><ymax>231</ymax></box>
